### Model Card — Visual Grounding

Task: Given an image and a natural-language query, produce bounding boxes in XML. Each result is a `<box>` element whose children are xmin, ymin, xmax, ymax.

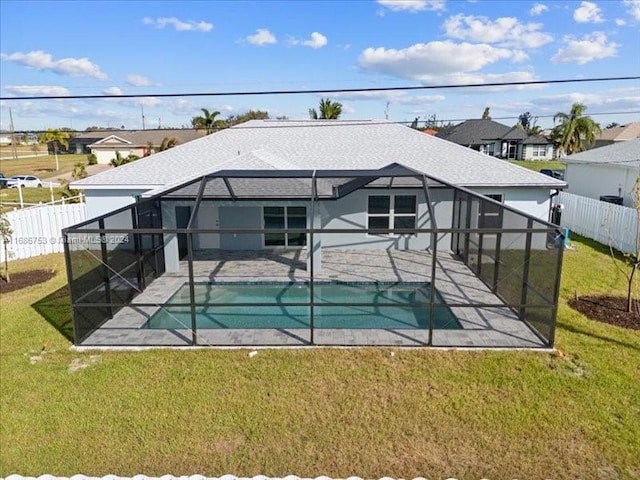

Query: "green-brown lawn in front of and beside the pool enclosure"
<box><xmin>0</xmin><ymin>238</ymin><xmax>640</xmax><ymax>479</ymax></box>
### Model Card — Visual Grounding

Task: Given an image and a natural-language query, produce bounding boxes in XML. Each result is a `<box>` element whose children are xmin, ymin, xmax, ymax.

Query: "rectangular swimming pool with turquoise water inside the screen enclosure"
<box><xmin>145</xmin><ymin>282</ymin><xmax>461</xmax><ymax>329</ymax></box>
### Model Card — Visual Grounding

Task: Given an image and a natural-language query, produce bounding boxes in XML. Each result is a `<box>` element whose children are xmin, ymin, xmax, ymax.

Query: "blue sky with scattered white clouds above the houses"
<box><xmin>0</xmin><ymin>0</ymin><xmax>640</xmax><ymax>131</ymax></box>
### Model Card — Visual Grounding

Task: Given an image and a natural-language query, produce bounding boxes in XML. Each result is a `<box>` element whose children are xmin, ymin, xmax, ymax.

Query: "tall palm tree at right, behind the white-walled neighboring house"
<box><xmin>552</xmin><ymin>103</ymin><xmax>600</xmax><ymax>155</ymax></box>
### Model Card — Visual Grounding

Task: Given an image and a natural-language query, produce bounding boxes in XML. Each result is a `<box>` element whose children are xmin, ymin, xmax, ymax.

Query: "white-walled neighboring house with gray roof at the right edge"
<box><xmin>563</xmin><ymin>138</ymin><xmax>640</xmax><ymax>207</ymax></box>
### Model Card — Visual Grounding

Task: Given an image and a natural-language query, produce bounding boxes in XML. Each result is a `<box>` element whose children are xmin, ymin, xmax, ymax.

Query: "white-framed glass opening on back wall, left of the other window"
<box><xmin>262</xmin><ymin>207</ymin><xmax>307</xmax><ymax>247</ymax></box>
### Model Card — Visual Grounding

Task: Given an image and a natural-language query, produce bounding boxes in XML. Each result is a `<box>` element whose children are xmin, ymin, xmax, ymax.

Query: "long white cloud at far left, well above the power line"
<box><xmin>0</xmin><ymin>50</ymin><xmax>107</xmax><ymax>80</ymax></box>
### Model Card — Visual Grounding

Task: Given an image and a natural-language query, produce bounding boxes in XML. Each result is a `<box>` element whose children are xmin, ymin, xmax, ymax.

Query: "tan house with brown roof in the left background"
<box><xmin>67</xmin><ymin>129</ymin><xmax>204</xmax><ymax>160</ymax></box>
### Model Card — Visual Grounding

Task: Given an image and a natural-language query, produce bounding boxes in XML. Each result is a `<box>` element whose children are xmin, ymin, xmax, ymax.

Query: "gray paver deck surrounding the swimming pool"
<box><xmin>80</xmin><ymin>250</ymin><xmax>546</xmax><ymax>348</ymax></box>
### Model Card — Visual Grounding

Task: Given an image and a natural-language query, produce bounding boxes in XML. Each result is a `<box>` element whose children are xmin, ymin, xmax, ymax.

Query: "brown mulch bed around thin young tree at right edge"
<box><xmin>569</xmin><ymin>295</ymin><xmax>640</xmax><ymax>330</ymax></box>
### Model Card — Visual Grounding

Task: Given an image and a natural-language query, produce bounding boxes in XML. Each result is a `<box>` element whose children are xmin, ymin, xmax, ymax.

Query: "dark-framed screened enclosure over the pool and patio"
<box><xmin>63</xmin><ymin>164</ymin><xmax>563</xmax><ymax>348</ymax></box>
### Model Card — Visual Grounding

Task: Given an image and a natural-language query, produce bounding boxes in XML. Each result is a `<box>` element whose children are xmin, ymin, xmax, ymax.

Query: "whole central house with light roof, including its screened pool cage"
<box><xmin>63</xmin><ymin>120</ymin><xmax>565</xmax><ymax>348</ymax></box>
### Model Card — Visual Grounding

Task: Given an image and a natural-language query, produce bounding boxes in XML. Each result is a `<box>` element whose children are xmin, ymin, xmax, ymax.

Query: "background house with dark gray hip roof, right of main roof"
<box><xmin>436</xmin><ymin>119</ymin><xmax>554</xmax><ymax>160</ymax></box>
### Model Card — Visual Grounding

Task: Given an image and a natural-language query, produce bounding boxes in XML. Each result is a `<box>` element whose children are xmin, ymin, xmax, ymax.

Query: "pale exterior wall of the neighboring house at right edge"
<box><xmin>565</xmin><ymin>163</ymin><xmax>640</xmax><ymax>207</ymax></box>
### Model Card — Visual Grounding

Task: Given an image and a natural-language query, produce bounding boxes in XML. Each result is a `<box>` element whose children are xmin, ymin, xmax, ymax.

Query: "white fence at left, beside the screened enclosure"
<box><xmin>0</xmin><ymin>202</ymin><xmax>87</xmax><ymax>262</ymax></box>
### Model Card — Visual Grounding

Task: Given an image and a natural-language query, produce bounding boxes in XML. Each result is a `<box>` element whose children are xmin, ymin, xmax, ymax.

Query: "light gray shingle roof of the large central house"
<box><xmin>72</xmin><ymin>120</ymin><xmax>564</xmax><ymax>188</ymax></box>
